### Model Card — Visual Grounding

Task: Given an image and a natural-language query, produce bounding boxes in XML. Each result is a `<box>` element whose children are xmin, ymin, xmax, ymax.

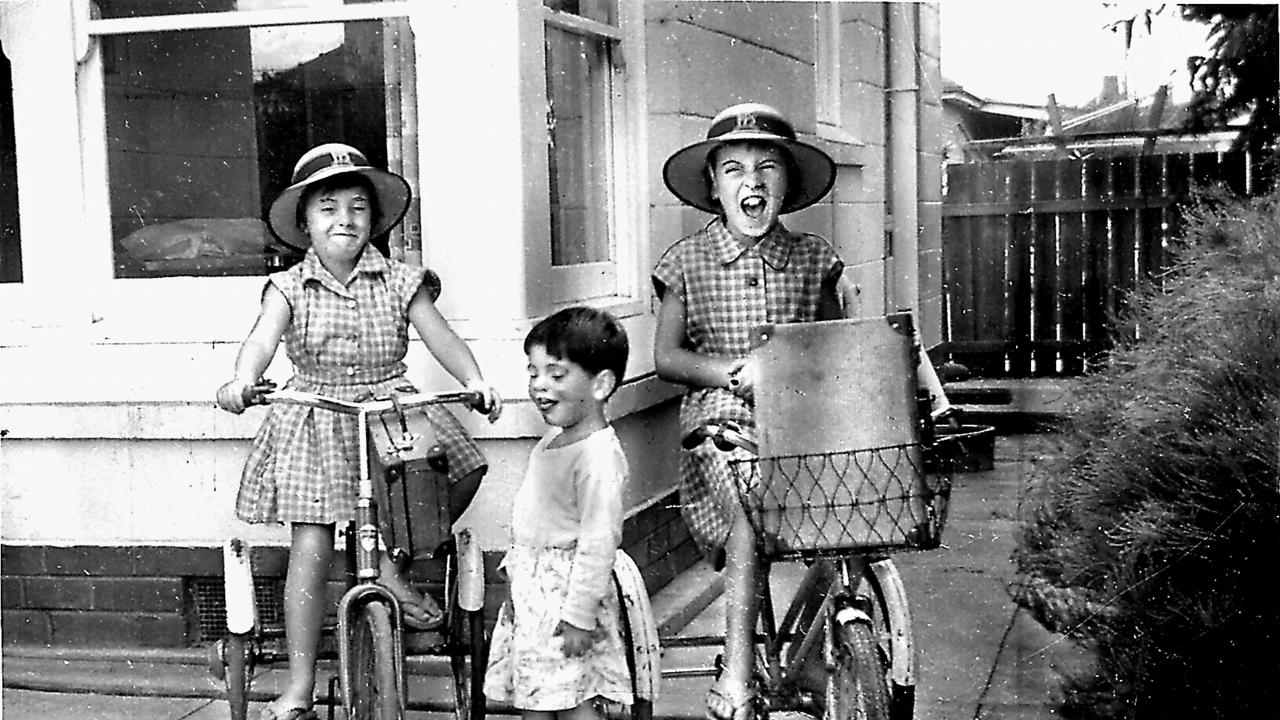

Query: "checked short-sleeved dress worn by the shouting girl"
<box><xmin>653</xmin><ymin>219</ymin><xmax>844</xmax><ymax>566</ymax></box>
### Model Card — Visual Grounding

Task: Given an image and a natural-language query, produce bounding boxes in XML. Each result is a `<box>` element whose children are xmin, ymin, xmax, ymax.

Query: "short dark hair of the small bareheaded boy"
<box><xmin>525</xmin><ymin>306</ymin><xmax>630</xmax><ymax>395</ymax></box>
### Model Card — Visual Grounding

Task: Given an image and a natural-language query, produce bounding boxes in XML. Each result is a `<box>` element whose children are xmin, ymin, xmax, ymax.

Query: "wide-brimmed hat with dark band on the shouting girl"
<box><xmin>662</xmin><ymin>102</ymin><xmax>836</xmax><ymax>214</ymax></box>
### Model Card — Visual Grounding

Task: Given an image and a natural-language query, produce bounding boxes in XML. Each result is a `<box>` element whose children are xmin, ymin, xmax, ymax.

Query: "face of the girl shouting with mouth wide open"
<box><xmin>710</xmin><ymin>142</ymin><xmax>788</xmax><ymax>240</ymax></box>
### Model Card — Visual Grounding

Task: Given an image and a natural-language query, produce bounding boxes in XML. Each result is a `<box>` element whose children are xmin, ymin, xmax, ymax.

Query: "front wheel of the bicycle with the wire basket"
<box><xmin>824</xmin><ymin>620</ymin><xmax>890</xmax><ymax>720</ymax></box>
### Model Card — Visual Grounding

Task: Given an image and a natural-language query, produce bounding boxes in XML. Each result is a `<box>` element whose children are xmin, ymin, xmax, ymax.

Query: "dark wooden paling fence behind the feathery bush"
<box><xmin>942</xmin><ymin>152</ymin><xmax>1263</xmax><ymax>378</ymax></box>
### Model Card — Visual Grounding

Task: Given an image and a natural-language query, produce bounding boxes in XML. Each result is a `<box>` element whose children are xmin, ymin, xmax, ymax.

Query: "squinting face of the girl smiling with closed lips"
<box><xmin>301</xmin><ymin>186</ymin><xmax>374</xmax><ymax>281</ymax></box>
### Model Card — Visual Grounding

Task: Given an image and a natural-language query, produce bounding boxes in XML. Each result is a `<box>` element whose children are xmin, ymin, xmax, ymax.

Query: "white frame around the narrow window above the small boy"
<box><xmin>521</xmin><ymin>0</ymin><xmax>648</xmax><ymax>315</ymax></box>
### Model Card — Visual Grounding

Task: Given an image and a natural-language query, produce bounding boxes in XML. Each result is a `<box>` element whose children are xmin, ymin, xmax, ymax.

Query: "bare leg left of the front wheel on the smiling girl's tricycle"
<box><xmin>271</xmin><ymin>523</ymin><xmax>334</xmax><ymax>712</ymax></box>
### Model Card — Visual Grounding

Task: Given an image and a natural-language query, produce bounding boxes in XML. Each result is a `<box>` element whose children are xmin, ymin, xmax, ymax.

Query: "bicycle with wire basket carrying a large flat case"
<box><xmin>660</xmin><ymin>314</ymin><xmax>950</xmax><ymax>720</ymax></box>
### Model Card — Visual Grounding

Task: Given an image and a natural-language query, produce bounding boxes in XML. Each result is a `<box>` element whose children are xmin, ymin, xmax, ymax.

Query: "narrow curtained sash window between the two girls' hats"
<box><xmin>541</xmin><ymin>0</ymin><xmax>637</xmax><ymax>302</ymax></box>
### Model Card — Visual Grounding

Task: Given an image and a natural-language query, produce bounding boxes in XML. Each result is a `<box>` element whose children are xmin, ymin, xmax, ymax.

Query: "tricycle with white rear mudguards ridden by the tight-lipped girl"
<box><xmin>210</xmin><ymin>389</ymin><xmax>488</xmax><ymax>720</ymax></box>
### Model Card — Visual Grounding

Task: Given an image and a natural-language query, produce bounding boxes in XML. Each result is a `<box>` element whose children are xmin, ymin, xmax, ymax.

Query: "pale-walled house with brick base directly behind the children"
<box><xmin>0</xmin><ymin>0</ymin><xmax>942</xmax><ymax>646</ymax></box>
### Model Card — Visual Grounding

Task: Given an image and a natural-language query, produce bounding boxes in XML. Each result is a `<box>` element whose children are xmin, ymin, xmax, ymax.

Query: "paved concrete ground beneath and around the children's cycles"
<box><xmin>0</xmin><ymin>427</ymin><xmax>1088</xmax><ymax>720</ymax></box>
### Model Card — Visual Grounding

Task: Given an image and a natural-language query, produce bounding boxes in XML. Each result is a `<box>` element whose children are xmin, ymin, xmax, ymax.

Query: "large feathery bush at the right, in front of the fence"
<box><xmin>1015</xmin><ymin>185</ymin><xmax>1280</xmax><ymax>719</ymax></box>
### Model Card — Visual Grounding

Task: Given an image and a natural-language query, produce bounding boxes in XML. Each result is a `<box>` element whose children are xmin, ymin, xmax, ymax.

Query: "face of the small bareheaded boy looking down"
<box><xmin>529</xmin><ymin>345</ymin><xmax>612</xmax><ymax>432</ymax></box>
